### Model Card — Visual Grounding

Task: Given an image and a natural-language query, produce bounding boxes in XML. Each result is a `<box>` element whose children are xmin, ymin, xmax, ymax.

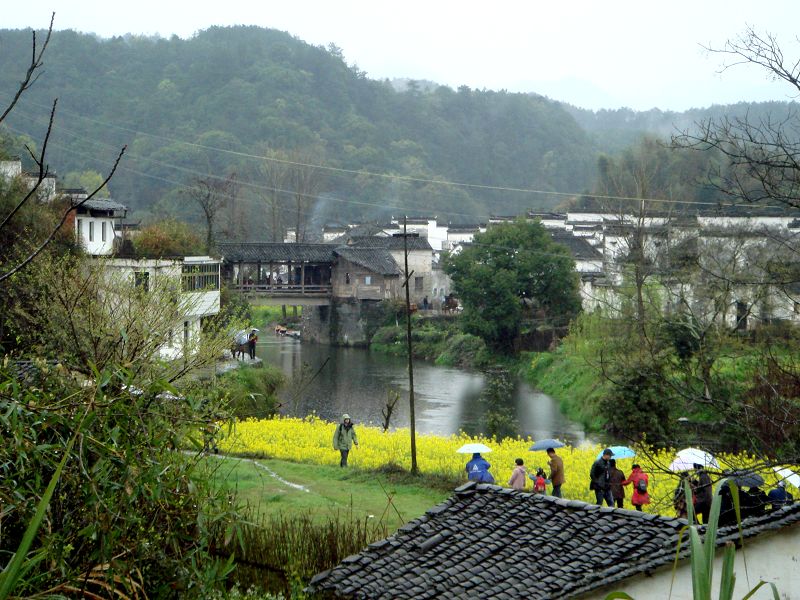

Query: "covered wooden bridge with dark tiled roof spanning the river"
<box><xmin>219</xmin><ymin>242</ymin><xmax>336</xmax><ymax>305</ymax></box>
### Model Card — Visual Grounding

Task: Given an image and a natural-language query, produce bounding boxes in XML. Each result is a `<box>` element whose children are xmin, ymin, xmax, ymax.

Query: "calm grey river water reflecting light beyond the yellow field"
<box><xmin>256</xmin><ymin>333</ymin><xmax>586</xmax><ymax>444</ymax></box>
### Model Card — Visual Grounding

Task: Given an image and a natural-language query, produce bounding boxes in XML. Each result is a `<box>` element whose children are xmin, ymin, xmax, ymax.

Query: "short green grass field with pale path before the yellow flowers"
<box><xmin>209</xmin><ymin>457</ymin><xmax>450</xmax><ymax>531</ymax></box>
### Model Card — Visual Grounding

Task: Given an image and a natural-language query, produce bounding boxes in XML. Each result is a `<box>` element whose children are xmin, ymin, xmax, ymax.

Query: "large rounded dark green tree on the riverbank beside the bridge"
<box><xmin>445</xmin><ymin>220</ymin><xmax>581</xmax><ymax>353</ymax></box>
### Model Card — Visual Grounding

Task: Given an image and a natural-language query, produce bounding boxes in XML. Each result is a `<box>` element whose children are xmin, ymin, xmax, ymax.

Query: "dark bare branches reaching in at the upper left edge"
<box><xmin>0</xmin><ymin>13</ymin><xmax>125</xmax><ymax>282</ymax></box>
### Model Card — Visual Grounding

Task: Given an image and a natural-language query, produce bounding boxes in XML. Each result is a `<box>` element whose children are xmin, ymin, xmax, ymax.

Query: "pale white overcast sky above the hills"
<box><xmin>6</xmin><ymin>0</ymin><xmax>800</xmax><ymax>110</ymax></box>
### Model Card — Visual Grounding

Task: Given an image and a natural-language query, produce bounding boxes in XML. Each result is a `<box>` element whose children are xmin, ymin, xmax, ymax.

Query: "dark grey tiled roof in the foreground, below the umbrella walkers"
<box><xmin>309</xmin><ymin>483</ymin><xmax>800</xmax><ymax>599</ymax></box>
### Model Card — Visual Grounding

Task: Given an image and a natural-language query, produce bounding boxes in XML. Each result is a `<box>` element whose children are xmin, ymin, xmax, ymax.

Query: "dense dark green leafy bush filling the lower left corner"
<box><xmin>0</xmin><ymin>359</ymin><xmax>244</xmax><ymax>598</ymax></box>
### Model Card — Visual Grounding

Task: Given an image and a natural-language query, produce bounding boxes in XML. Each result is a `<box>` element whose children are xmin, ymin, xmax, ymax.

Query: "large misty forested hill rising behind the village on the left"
<box><xmin>0</xmin><ymin>27</ymin><xmax>595</xmax><ymax>230</ymax></box>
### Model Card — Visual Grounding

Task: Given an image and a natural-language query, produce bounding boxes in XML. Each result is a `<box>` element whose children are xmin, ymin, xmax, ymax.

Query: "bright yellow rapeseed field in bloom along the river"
<box><xmin>219</xmin><ymin>416</ymin><xmax>792</xmax><ymax>514</ymax></box>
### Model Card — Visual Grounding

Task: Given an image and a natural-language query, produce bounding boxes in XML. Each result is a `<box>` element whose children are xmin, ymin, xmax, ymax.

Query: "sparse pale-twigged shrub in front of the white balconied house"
<box><xmin>7</xmin><ymin>255</ymin><xmax>241</xmax><ymax>386</ymax></box>
